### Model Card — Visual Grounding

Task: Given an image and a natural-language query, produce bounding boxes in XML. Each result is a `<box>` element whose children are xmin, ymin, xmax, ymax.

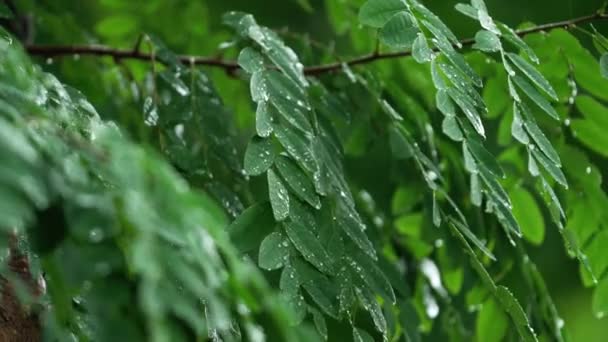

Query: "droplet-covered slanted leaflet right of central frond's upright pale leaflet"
<box><xmin>276</xmin><ymin>156</ymin><xmax>321</xmax><ymax>209</ymax></box>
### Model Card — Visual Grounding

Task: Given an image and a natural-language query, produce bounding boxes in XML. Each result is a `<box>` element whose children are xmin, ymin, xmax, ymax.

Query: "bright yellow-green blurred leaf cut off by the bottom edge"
<box><xmin>475</xmin><ymin>298</ymin><xmax>509</xmax><ymax>342</ymax></box>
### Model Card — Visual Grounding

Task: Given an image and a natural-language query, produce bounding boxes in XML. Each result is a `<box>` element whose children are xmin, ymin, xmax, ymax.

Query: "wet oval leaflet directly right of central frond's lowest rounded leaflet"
<box><xmin>283</xmin><ymin>221</ymin><xmax>333</xmax><ymax>274</ymax></box>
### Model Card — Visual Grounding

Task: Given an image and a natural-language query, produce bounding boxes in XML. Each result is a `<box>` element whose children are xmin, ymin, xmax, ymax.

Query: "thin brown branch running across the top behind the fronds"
<box><xmin>25</xmin><ymin>12</ymin><xmax>608</xmax><ymax>75</ymax></box>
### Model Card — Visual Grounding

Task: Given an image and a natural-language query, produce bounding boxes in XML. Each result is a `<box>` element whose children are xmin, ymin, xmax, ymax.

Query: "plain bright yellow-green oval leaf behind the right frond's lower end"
<box><xmin>509</xmin><ymin>187</ymin><xmax>545</xmax><ymax>245</ymax></box>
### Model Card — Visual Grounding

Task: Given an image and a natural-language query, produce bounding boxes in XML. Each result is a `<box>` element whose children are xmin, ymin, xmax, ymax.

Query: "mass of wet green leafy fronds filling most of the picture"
<box><xmin>0</xmin><ymin>0</ymin><xmax>608</xmax><ymax>341</ymax></box>
